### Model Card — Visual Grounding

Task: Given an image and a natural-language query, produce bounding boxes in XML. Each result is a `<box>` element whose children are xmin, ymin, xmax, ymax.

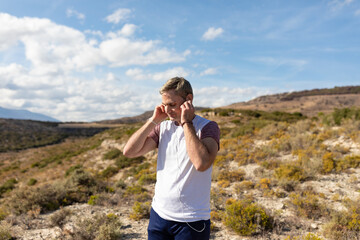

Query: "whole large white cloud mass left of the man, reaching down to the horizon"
<box><xmin>0</xmin><ymin>13</ymin><xmax>191</xmax><ymax>121</ymax></box>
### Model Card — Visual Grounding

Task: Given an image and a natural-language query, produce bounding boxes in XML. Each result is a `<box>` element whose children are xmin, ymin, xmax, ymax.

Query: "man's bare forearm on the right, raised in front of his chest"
<box><xmin>183</xmin><ymin>124</ymin><xmax>213</xmax><ymax>171</ymax></box>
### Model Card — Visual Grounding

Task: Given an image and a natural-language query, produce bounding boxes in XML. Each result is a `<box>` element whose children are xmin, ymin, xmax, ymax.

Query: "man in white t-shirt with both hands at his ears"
<box><xmin>124</xmin><ymin>77</ymin><xmax>220</xmax><ymax>240</ymax></box>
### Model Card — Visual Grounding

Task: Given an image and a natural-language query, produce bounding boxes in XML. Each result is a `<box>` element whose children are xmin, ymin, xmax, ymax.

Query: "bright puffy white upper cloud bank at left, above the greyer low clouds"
<box><xmin>0</xmin><ymin>14</ymin><xmax>190</xmax><ymax>75</ymax></box>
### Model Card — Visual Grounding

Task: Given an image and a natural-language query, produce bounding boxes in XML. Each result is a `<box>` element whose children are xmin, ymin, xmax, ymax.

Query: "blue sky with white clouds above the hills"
<box><xmin>0</xmin><ymin>0</ymin><xmax>360</xmax><ymax>122</ymax></box>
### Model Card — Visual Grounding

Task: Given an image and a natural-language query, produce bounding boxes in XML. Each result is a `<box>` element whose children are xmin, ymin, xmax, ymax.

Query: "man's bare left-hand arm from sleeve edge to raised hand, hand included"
<box><xmin>123</xmin><ymin>105</ymin><xmax>167</xmax><ymax>158</ymax></box>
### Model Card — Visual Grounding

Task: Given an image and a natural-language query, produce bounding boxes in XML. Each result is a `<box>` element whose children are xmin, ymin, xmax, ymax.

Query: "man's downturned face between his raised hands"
<box><xmin>161</xmin><ymin>90</ymin><xmax>185</xmax><ymax>122</ymax></box>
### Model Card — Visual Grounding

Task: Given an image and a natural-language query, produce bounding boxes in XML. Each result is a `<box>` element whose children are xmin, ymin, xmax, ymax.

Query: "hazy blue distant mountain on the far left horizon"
<box><xmin>0</xmin><ymin>107</ymin><xmax>60</xmax><ymax>122</ymax></box>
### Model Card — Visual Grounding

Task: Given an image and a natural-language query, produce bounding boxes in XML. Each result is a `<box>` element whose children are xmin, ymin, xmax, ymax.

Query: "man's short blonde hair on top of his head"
<box><xmin>160</xmin><ymin>77</ymin><xmax>193</xmax><ymax>99</ymax></box>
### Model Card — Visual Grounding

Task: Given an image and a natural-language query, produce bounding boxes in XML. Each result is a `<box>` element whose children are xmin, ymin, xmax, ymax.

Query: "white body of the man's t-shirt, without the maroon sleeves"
<box><xmin>152</xmin><ymin>116</ymin><xmax>212</xmax><ymax>222</ymax></box>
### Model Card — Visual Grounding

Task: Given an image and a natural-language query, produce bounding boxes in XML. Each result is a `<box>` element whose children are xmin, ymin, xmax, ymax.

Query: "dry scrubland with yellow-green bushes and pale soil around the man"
<box><xmin>0</xmin><ymin>108</ymin><xmax>360</xmax><ymax>240</ymax></box>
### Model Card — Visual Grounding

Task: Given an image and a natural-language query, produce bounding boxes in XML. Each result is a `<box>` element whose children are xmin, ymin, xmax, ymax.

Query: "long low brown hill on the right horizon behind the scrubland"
<box><xmin>224</xmin><ymin>86</ymin><xmax>360</xmax><ymax>116</ymax></box>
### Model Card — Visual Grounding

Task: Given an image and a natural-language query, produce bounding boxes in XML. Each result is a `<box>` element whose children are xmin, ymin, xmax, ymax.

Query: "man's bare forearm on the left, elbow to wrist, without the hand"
<box><xmin>123</xmin><ymin>120</ymin><xmax>155</xmax><ymax>157</ymax></box>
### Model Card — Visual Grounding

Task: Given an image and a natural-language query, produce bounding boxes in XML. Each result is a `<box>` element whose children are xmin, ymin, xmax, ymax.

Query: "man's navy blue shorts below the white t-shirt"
<box><xmin>148</xmin><ymin>208</ymin><xmax>210</xmax><ymax>240</ymax></box>
